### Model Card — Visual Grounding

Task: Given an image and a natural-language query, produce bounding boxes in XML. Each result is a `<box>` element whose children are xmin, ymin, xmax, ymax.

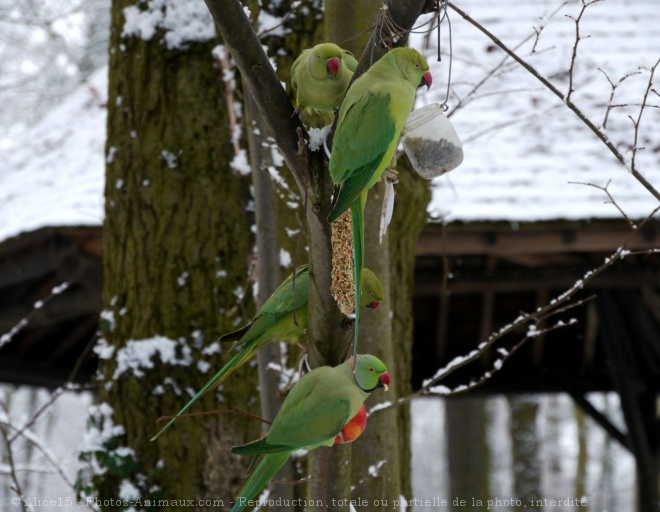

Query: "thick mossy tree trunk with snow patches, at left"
<box><xmin>83</xmin><ymin>1</ymin><xmax>261</xmax><ymax>510</ymax></box>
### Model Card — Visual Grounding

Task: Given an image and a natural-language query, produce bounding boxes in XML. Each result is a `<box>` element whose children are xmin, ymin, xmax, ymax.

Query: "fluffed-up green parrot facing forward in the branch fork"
<box><xmin>291</xmin><ymin>43</ymin><xmax>357</xmax><ymax>128</ymax></box>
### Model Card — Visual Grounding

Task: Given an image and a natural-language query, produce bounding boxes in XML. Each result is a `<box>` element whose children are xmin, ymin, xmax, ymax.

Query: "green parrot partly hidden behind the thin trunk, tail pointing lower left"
<box><xmin>151</xmin><ymin>265</ymin><xmax>384</xmax><ymax>441</ymax></box>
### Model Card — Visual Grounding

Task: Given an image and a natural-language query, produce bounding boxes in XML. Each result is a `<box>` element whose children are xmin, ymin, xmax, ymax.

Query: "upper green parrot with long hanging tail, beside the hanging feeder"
<box><xmin>328</xmin><ymin>48</ymin><xmax>433</xmax><ymax>360</ymax></box>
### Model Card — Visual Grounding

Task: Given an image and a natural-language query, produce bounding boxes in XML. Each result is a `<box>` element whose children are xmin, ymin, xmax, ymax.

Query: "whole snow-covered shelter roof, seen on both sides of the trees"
<box><xmin>0</xmin><ymin>0</ymin><xmax>660</xmax><ymax>246</ymax></box>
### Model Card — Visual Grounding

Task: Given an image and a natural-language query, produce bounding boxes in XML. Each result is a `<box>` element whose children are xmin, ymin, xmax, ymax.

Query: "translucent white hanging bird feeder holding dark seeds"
<box><xmin>403</xmin><ymin>103</ymin><xmax>463</xmax><ymax>180</ymax></box>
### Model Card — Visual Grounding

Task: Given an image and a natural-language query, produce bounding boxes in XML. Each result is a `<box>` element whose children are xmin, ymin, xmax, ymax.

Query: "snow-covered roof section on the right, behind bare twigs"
<box><xmin>412</xmin><ymin>0</ymin><xmax>660</xmax><ymax>222</ymax></box>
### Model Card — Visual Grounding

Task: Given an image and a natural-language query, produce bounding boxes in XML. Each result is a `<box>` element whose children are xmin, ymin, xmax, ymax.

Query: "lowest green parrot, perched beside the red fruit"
<box><xmin>231</xmin><ymin>354</ymin><xmax>390</xmax><ymax>512</ymax></box>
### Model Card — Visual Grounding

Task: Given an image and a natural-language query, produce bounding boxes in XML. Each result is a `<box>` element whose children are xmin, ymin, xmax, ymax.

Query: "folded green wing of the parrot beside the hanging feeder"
<box><xmin>328</xmin><ymin>90</ymin><xmax>396</xmax><ymax>222</ymax></box>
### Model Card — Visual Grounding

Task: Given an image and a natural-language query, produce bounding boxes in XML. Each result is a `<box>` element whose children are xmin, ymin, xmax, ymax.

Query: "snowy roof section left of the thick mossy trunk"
<box><xmin>0</xmin><ymin>68</ymin><xmax>108</xmax><ymax>241</ymax></box>
